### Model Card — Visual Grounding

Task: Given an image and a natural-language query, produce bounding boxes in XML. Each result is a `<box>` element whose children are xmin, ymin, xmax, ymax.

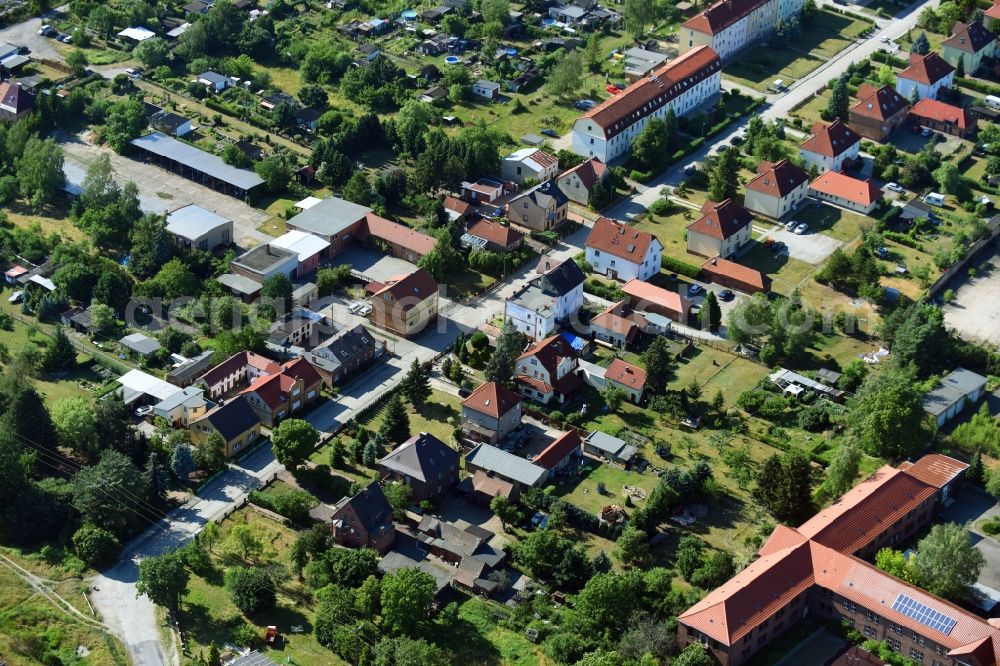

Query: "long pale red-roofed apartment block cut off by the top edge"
<box><xmin>680</xmin><ymin>0</ymin><xmax>805</xmax><ymax>60</ymax></box>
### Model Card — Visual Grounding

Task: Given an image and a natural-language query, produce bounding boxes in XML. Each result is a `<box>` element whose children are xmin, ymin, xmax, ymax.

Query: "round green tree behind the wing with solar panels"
<box><xmin>914</xmin><ymin>523</ymin><xmax>986</xmax><ymax>601</ymax></box>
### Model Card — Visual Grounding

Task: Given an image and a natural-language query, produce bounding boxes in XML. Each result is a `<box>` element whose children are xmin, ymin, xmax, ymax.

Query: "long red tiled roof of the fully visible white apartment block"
<box><xmin>577</xmin><ymin>46</ymin><xmax>722</xmax><ymax>138</ymax></box>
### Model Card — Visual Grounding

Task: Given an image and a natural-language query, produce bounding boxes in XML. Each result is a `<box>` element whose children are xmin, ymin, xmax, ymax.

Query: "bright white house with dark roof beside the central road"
<box><xmin>504</xmin><ymin>257</ymin><xmax>586</xmax><ymax>340</ymax></box>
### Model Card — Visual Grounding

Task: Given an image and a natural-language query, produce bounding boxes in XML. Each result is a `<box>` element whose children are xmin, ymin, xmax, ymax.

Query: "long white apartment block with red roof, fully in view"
<box><xmin>573</xmin><ymin>46</ymin><xmax>722</xmax><ymax>164</ymax></box>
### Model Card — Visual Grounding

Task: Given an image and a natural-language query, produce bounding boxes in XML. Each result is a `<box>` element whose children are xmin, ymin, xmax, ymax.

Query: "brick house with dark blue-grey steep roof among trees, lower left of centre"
<box><xmin>330</xmin><ymin>481</ymin><xmax>396</xmax><ymax>554</ymax></box>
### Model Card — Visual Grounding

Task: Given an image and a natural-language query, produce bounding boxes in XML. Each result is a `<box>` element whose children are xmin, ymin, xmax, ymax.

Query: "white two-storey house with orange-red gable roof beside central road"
<box><xmin>587</xmin><ymin>217</ymin><xmax>663</xmax><ymax>282</ymax></box>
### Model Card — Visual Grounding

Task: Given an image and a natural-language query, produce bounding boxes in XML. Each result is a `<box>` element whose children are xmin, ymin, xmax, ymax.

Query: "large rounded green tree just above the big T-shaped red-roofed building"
<box><xmin>848</xmin><ymin>367</ymin><xmax>926</xmax><ymax>458</ymax></box>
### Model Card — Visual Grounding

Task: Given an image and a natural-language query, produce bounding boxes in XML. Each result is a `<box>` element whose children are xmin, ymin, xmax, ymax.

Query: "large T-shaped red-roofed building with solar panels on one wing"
<box><xmin>678</xmin><ymin>454</ymin><xmax>976</xmax><ymax>666</ymax></box>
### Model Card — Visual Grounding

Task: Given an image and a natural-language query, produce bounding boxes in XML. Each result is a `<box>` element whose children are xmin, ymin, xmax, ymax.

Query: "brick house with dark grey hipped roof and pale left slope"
<box><xmin>378</xmin><ymin>432</ymin><xmax>460</xmax><ymax>503</ymax></box>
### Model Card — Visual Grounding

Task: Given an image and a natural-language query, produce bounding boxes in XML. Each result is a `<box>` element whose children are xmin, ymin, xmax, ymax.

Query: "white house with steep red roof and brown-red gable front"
<box><xmin>514</xmin><ymin>335</ymin><xmax>583</xmax><ymax>405</ymax></box>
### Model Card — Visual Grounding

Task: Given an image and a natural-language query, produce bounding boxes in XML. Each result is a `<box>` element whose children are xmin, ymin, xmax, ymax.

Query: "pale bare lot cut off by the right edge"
<box><xmin>944</xmin><ymin>255</ymin><xmax>1000</xmax><ymax>345</ymax></box>
